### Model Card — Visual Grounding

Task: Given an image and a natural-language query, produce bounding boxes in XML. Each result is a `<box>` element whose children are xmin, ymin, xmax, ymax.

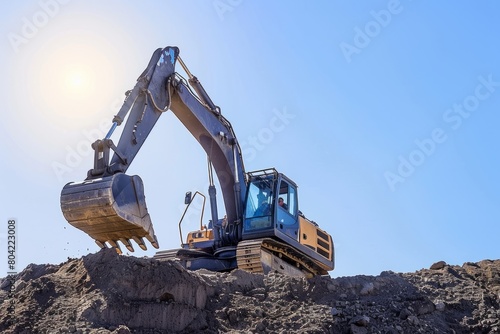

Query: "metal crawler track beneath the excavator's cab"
<box><xmin>236</xmin><ymin>238</ymin><xmax>327</xmax><ymax>277</ymax></box>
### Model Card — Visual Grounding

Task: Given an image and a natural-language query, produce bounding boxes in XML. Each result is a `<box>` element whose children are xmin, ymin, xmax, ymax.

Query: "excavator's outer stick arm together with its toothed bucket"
<box><xmin>61</xmin><ymin>47</ymin><xmax>179</xmax><ymax>253</ymax></box>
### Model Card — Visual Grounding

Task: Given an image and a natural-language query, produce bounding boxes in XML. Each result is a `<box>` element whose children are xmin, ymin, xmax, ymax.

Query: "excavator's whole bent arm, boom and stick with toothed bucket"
<box><xmin>61</xmin><ymin>47</ymin><xmax>246</xmax><ymax>252</ymax></box>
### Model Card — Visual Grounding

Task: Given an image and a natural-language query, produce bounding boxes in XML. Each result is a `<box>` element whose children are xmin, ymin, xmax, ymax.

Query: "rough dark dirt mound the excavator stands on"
<box><xmin>0</xmin><ymin>249</ymin><xmax>500</xmax><ymax>334</ymax></box>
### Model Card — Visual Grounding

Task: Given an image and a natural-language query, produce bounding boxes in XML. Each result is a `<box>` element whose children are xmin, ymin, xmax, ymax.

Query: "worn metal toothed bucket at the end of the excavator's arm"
<box><xmin>61</xmin><ymin>173</ymin><xmax>159</xmax><ymax>253</ymax></box>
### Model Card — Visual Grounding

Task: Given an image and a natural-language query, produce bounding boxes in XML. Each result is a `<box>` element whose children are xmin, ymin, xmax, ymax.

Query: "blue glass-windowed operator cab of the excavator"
<box><xmin>243</xmin><ymin>169</ymin><xmax>299</xmax><ymax>240</ymax></box>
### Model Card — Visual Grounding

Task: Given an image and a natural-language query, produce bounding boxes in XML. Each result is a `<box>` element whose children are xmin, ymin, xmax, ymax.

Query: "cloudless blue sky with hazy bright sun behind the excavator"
<box><xmin>0</xmin><ymin>0</ymin><xmax>500</xmax><ymax>277</ymax></box>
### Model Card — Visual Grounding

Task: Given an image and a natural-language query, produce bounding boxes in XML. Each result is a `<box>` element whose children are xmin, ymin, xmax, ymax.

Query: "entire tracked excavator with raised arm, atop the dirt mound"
<box><xmin>60</xmin><ymin>46</ymin><xmax>334</xmax><ymax>277</ymax></box>
